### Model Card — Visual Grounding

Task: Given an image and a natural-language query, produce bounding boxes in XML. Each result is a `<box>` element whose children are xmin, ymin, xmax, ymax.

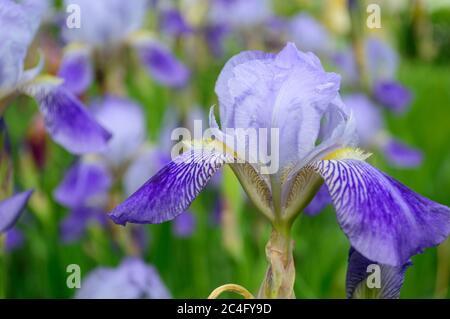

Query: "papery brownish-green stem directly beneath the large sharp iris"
<box><xmin>258</xmin><ymin>227</ymin><xmax>295</xmax><ymax>299</ymax></box>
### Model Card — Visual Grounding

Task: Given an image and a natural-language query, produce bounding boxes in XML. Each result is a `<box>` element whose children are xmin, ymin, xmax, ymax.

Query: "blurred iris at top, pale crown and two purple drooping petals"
<box><xmin>60</xmin><ymin>0</ymin><xmax>189</xmax><ymax>91</ymax></box>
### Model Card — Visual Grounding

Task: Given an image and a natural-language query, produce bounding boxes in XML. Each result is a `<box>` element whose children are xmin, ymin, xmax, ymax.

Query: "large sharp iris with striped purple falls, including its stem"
<box><xmin>110</xmin><ymin>43</ymin><xmax>450</xmax><ymax>298</ymax></box>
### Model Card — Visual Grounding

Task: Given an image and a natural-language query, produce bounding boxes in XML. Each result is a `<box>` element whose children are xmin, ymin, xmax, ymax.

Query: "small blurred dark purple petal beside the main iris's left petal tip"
<box><xmin>60</xmin><ymin>207</ymin><xmax>106</xmax><ymax>243</ymax></box>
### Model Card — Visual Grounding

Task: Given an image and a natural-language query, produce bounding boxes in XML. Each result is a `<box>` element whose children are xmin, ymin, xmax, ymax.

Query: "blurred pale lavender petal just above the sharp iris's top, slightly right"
<box><xmin>289</xmin><ymin>12</ymin><xmax>332</xmax><ymax>54</ymax></box>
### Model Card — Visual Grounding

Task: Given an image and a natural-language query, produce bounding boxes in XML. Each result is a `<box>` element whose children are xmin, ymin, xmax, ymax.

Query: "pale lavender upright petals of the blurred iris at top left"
<box><xmin>62</xmin><ymin>0</ymin><xmax>147</xmax><ymax>46</ymax></box>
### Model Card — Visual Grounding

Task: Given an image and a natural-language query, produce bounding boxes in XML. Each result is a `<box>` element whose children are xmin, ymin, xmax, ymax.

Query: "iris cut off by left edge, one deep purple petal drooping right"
<box><xmin>0</xmin><ymin>0</ymin><xmax>110</xmax><ymax>154</ymax></box>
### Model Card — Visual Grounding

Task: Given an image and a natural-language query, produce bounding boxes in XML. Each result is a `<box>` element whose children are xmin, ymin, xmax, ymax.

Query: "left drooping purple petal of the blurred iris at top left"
<box><xmin>58</xmin><ymin>48</ymin><xmax>94</xmax><ymax>95</ymax></box>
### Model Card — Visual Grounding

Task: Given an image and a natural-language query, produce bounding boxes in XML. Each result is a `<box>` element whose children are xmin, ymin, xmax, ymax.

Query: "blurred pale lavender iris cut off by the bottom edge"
<box><xmin>75</xmin><ymin>258</ymin><xmax>170</xmax><ymax>299</ymax></box>
